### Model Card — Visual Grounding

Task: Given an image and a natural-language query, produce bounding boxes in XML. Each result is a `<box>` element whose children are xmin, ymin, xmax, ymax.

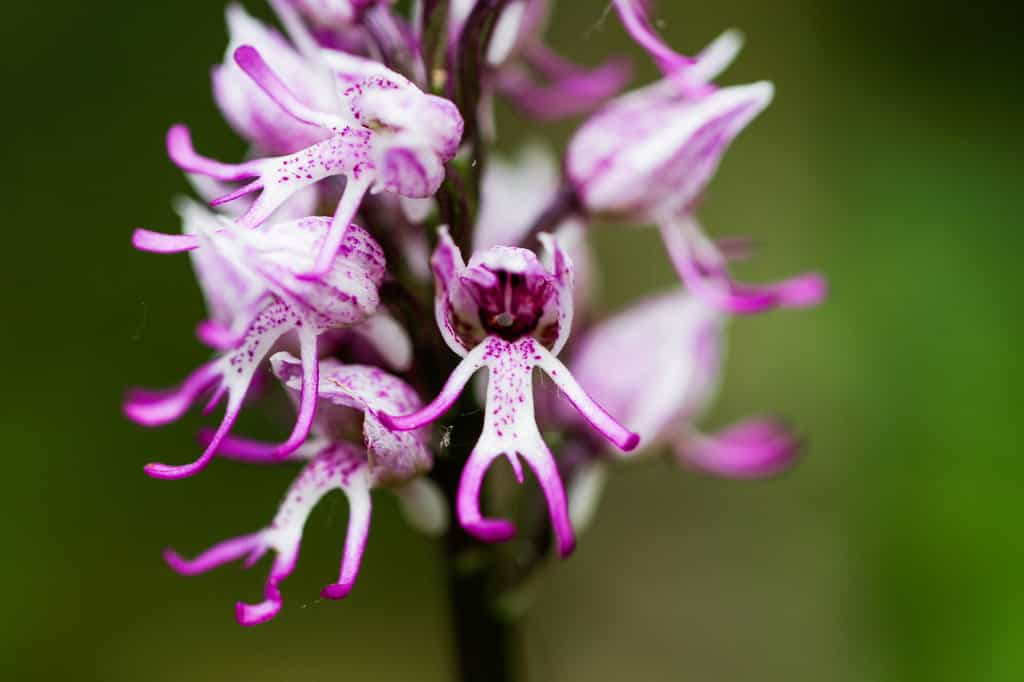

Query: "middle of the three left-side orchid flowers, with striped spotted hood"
<box><xmin>125</xmin><ymin>217</ymin><xmax>385</xmax><ymax>478</ymax></box>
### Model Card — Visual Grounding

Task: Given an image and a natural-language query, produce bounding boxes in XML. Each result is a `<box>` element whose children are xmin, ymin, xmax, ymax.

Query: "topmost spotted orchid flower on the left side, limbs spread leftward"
<box><xmin>167</xmin><ymin>45</ymin><xmax>463</xmax><ymax>279</ymax></box>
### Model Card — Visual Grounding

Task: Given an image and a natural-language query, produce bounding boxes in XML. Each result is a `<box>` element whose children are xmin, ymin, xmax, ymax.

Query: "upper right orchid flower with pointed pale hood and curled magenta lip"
<box><xmin>565</xmin><ymin>45</ymin><xmax>825</xmax><ymax>313</ymax></box>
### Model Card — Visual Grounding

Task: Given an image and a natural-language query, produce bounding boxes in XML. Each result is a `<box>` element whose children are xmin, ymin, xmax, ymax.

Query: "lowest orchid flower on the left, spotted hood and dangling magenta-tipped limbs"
<box><xmin>164</xmin><ymin>353</ymin><xmax>447</xmax><ymax>626</ymax></box>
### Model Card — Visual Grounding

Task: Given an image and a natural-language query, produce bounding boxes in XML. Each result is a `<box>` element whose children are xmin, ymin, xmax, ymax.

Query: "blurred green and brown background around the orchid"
<box><xmin>0</xmin><ymin>0</ymin><xmax>1024</xmax><ymax>682</ymax></box>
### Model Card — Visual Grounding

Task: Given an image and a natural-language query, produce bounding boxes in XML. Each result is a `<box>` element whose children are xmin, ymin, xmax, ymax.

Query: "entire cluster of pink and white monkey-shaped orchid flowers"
<box><xmin>125</xmin><ymin>0</ymin><xmax>824</xmax><ymax>625</ymax></box>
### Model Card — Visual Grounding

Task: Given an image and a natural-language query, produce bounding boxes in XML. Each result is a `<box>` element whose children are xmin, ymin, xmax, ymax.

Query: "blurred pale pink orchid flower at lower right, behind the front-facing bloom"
<box><xmin>559</xmin><ymin>289</ymin><xmax>800</xmax><ymax>527</ymax></box>
